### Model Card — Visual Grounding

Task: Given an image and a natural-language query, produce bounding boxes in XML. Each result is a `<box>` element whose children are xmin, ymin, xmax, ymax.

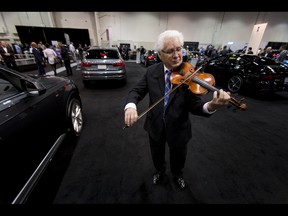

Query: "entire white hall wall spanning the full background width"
<box><xmin>0</xmin><ymin>12</ymin><xmax>288</xmax><ymax>49</ymax></box>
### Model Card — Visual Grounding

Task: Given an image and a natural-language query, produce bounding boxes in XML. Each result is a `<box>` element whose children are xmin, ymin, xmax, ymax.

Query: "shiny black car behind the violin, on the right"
<box><xmin>202</xmin><ymin>53</ymin><xmax>288</xmax><ymax>93</ymax></box>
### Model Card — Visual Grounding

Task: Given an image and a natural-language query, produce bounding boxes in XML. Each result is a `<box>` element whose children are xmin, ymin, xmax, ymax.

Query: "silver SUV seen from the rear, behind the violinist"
<box><xmin>80</xmin><ymin>47</ymin><xmax>127</xmax><ymax>86</ymax></box>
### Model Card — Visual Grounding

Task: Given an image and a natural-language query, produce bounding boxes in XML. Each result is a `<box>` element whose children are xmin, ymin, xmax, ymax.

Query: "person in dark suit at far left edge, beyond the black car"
<box><xmin>0</xmin><ymin>41</ymin><xmax>18</xmax><ymax>71</ymax></box>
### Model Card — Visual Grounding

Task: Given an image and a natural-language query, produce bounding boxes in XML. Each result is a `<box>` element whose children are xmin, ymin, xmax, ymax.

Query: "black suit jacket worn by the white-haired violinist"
<box><xmin>126</xmin><ymin>62</ymin><xmax>211</xmax><ymax>145</ymax></box>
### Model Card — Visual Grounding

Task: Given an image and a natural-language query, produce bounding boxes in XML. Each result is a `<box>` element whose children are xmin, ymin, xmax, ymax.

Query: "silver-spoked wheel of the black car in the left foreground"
<box><xmin>67</xmin><ymin>98</ymin><xmax>83</xmax><ymax>137</ymax></box>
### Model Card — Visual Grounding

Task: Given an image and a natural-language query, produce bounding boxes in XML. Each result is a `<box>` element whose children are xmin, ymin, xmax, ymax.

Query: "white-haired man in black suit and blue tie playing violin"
<box><xmin>124</xmin><ymin>30</ymin><xmax>230</xmax><ymax>189</ymax></box>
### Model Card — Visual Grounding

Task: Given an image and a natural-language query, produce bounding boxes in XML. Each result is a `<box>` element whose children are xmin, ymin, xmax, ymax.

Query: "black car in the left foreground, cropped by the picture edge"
<box><xmin>0</xmin><ymin>66</ymin><xmax>83</xmax><ymax>204</ymax></box>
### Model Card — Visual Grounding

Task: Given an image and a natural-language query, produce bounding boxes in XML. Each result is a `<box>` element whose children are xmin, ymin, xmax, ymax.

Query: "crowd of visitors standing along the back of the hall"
<box><xmin>0</xmin><ymin>37</ymin><xmax>288</xmax><ymax>76</ymax></box>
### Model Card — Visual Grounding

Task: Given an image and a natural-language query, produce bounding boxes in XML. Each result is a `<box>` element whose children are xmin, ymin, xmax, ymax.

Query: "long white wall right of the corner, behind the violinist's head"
<box><xmin>99</xmin><ymin>12</ymin><xmax>288</xmax><ymax>49</ymax></box>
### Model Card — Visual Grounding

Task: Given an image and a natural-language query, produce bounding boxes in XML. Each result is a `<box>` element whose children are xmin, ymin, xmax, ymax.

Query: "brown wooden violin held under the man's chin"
<box><xmin>169</xmin><ymin>62</ymin><xmax>247</xmax><ymax>110</ymax></box>
